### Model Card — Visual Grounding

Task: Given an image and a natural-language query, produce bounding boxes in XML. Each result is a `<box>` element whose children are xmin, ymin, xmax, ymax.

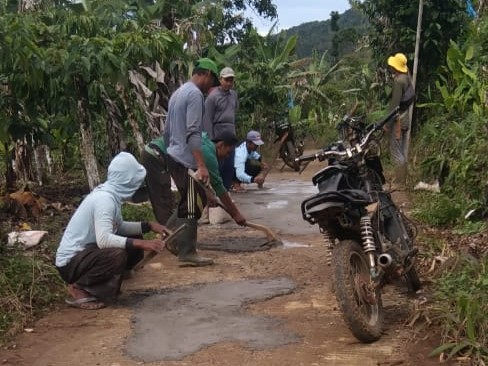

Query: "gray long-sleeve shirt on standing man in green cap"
<box><xmin>164</xmin><ymin>81</ymin><xmax>204</xmax><ymax>169</ymax></box>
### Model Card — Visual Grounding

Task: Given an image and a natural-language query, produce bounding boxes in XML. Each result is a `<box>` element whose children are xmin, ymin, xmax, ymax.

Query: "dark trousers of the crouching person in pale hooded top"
<box><xmin>58</xmin><ymin>243</ymin><xmax>144</xmax><ymax>301</ymax></box>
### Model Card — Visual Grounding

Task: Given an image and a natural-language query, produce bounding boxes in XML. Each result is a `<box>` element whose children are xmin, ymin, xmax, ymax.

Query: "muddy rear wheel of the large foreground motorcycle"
<box><xmin>332</xmin><ymin>240</ymin><xmax>383</xmax><ymax>343</ymax></box>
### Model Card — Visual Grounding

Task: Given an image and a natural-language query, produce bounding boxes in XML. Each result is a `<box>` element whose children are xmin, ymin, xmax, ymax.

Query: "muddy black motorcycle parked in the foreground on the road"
<box><xmin>297</xmin><ymin>106</ymin><xmax>421</xmax><ymax>343</ymax></box>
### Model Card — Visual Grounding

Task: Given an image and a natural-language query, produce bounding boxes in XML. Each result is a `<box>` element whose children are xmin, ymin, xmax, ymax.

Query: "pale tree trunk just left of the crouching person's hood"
<box><xmin>76</xmin><ymin>88</ymin><xmax>100</xmax><ymax>190</ymax></box>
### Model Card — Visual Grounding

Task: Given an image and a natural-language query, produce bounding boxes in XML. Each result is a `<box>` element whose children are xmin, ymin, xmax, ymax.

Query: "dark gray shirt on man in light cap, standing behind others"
<box><xmin>203</xmin><ymin>87</ymin><xmax>239</xmax><ymax>140</ymax></box>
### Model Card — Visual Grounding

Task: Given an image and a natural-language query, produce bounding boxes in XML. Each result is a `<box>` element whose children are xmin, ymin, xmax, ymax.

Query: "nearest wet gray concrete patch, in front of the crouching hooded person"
<box><xmin>125</xmin><ymin>278</ymin><xmax>300</xmax><ymax>362</ymax></box>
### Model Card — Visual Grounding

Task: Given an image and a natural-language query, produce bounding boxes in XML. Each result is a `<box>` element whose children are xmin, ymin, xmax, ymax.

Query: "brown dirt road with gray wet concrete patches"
<box><xmin>0</xmin><ymin>161</ymin><xmax>446</xmax><ymax>366</ymax></box>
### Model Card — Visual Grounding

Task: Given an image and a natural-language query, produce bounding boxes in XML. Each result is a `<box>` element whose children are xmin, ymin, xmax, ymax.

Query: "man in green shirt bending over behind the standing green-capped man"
<box><xmin>141</xmin><ymin>131</ymin><xmax>246</xmax><ymax>266</ymax></box>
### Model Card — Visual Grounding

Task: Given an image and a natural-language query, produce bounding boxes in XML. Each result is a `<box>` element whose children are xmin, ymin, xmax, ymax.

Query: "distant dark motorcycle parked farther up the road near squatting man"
<box><xmin>274</xmin><ymin>119</ymin><xmax>304</xmax><ymax>172</ymax></box>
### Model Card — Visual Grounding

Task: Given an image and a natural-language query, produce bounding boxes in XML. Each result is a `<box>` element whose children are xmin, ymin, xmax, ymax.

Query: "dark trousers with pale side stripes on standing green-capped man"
<box><xmin>166</xmin><ymin>155</ymin><xmax>207</xmax><ymax>220</ymax></box>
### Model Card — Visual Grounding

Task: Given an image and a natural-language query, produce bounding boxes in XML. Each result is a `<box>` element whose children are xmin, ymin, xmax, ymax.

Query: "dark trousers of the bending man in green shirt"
<box><xmin>141</xmin><ymin>150</ymin><xmax>174</xmax><ymax>225</ymax></box>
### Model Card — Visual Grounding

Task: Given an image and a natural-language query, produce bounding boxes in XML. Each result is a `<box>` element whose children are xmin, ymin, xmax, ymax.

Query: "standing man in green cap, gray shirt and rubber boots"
<box><xmin>163</xmin><ymin>58</ymin><xmax>219</xmax><ymax>266</ymax></box>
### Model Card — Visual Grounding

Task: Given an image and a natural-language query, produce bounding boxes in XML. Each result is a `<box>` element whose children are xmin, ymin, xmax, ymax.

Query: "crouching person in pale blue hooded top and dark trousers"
<box><xmin>56</xmin><ymin>152</ymin><xmax>166</xmax><ymax>310</ymax></box>
